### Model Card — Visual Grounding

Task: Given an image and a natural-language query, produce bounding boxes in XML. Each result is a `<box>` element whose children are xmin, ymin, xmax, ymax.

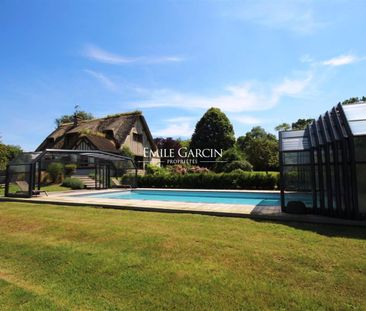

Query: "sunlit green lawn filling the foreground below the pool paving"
<box><xmin>0</xmin><ymin>203</ymin><xmax>366</xmax><ymax>311</ymax></box>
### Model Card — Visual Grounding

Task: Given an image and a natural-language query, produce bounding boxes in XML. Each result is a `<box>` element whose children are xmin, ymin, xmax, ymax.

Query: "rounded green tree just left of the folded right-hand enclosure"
<box><xmin>237</xmin><ymin>126</ymin><xmax>278</xmax><ymax>172</ymax></box>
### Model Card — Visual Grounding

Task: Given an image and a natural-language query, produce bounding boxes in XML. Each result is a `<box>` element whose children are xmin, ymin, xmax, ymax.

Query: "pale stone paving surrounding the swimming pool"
<box><xmin>0</xmin><ymin>188</ymin><xmax>366</xmax><ymax>227</ymax></box>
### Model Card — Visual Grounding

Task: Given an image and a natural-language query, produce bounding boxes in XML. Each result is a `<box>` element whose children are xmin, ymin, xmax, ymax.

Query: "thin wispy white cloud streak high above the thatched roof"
<box><xmin>83</xmin><ymin>45</ymin><xmax>184</xmax><ymax>65</ymax></box>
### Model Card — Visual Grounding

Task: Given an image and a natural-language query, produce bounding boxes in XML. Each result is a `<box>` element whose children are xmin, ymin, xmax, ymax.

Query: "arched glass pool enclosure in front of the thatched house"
<box><xmin>5</xmin><ymin>149</ymin><xmax>137</xmax><ymax>197</ymax></box>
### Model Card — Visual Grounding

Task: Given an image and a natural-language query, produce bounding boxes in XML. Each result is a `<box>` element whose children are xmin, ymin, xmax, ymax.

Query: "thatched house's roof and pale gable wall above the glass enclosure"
<box><xmin>36</xmin><ymin>112</ymin><xmax>160</xmax><ymax>168</ymax></box>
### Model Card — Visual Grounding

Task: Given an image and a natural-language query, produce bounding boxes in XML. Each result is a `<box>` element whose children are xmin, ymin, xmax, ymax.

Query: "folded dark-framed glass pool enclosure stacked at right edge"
<box><xmin>279</xmin><ymin>102</ymin><xmax>366</xmax><ymax>219</ymax></box>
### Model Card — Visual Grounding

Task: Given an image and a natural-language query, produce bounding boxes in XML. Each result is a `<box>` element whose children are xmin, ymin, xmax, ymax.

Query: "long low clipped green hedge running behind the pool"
<box><xmin>133</xmin><ymin>172</ymin><xmax>279</xmax><ymax>190</ymax></box>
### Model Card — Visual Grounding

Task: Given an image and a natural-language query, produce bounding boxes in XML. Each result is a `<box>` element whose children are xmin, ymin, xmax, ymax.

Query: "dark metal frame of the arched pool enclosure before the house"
<box><xmin>5</xmin><ymin>149</ymin><xmax>138</xmax><ymax>197</ymax></box>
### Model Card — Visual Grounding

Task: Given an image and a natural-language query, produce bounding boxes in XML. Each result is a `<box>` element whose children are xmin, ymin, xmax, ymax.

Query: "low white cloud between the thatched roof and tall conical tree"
<box><xmin>153</xmin><ymin>117</ymin><xmax>195</xmax><ymax>137</ymax></box>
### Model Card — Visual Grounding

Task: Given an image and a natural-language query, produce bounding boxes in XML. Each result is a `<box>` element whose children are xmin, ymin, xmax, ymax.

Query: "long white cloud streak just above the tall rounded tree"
<box><xmin>130</xmin><ymin>73</ymin><xmax>312</xmax><ymax>112</ymax></box>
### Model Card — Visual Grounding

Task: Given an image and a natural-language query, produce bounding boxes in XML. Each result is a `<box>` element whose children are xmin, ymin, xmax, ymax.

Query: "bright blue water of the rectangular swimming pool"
<box><xmin>75</xmin><ymin>190</ymin><xmax>280</xmax><ymax>206</ymax></box>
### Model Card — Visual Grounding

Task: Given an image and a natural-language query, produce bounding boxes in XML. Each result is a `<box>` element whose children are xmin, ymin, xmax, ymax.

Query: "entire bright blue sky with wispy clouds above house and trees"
<box><xmin>0</xmin><ymin>0</ymin><xmax>366</xmax><ymax>150</ymax></box>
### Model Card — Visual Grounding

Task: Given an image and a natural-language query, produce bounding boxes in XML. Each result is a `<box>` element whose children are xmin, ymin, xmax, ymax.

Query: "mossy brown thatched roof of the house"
<box><xmin>36</xmin><ymin>112</ymin><xmax>155</xmax><ymax>152</ymax></box>
